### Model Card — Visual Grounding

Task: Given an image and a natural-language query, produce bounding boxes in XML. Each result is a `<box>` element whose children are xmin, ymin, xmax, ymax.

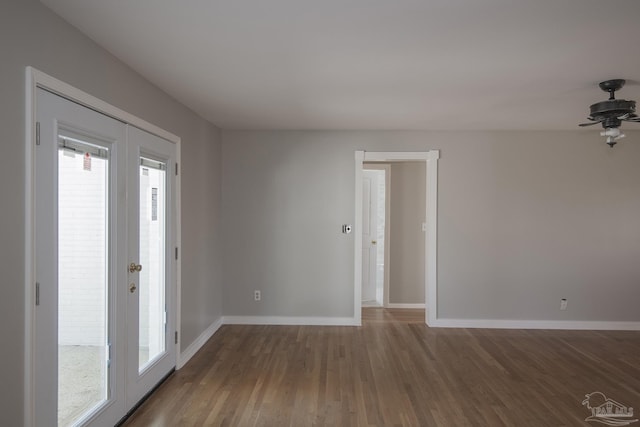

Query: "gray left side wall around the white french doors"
<box><xmin>0</xmin><ymin>0</ymin><xmax>222</xmax><ymax>426</ymax></box>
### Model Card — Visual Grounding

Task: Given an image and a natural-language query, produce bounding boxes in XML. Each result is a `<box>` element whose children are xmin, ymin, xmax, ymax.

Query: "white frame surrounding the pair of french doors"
<box><xmin>24</xmin><ymin>67</ymin><xmax>182</xmax><ymax>426</ymax></box>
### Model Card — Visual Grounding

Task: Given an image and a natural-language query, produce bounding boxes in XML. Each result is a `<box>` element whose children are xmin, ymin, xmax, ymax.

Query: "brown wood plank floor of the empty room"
<box><xmin>125</xmin><ymin>308</ymin><xmax>640</xmax><ymax>427</ymax></box>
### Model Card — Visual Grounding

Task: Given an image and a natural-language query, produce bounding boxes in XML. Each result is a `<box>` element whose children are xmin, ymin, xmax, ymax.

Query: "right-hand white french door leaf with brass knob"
<box><xmin>127</xmin><ymin>126</ymin><xmax>176</xmax><ymax>406</ymax></box>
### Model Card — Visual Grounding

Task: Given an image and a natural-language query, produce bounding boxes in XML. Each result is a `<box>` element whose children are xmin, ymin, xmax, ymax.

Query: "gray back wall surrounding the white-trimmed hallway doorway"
<box><xmin>222</xmin><ymin>131</ymin><xmax>640</xmax><ymax>321</ymax></box>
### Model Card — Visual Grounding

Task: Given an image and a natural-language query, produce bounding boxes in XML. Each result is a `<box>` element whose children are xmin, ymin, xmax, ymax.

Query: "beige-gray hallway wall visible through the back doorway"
<box><xmin>388</xmin><ymin>162</ymin><xmax>427</xmax><ymax>304</ymax></box>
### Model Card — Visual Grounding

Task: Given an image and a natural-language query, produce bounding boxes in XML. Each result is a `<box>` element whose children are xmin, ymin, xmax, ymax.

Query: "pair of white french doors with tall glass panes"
<box><xmin>34</xmin><ymin>89</ymin><xmax>176</xmax><ymax>426</ymax></box>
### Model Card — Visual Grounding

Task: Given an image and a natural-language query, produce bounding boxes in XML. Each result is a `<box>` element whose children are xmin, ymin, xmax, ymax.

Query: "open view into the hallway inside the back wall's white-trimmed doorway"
<box><xmin>362</xmin><ymin>161</ymin><xmax>426</xmax><ymax>310</ymax></box>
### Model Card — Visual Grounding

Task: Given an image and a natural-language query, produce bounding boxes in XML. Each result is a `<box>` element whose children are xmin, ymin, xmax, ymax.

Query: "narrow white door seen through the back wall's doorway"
<box><xmin>362</xmin><ymin>169</ymin><xmax>378</xmax><ymax>305</ymax></box>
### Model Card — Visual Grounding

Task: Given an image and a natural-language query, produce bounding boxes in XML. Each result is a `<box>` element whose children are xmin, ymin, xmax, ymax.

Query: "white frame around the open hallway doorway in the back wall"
<box><xmin>353</xmin><ymin>150</ymin><xmax>440</xmax><ymax>325</ymax></box>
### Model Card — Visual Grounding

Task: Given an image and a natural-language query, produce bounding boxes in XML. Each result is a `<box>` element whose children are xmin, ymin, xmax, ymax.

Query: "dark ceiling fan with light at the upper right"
<box><xmin>578</xmin><ymin>79</ymin><xmax>640</xmax><ymax>147</ymax></box>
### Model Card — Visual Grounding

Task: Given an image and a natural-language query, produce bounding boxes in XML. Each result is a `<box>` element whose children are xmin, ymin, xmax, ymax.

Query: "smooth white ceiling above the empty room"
<box><xmin>42</xmin><ymin>0</ymin><xmax>640</xmax><ymax>130</ymax></box>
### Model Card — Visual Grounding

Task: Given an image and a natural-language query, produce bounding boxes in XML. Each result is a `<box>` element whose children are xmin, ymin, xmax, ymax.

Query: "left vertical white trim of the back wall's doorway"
<box><xmin>352</xmin><ymin>151</ymin><xmax>365</xmax><ymax>326</ymax></box>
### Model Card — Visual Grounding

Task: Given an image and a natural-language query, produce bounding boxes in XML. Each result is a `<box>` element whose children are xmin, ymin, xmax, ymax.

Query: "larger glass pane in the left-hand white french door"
<box><xmin>58</xmin><ymin>136</ymin><xmax>109</xmax><ymax>426</ymax></box>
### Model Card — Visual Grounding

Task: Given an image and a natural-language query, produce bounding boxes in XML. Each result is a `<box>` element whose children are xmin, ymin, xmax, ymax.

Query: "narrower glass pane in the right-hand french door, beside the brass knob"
<box><xmin>138</xmin><ymin>157</ymin><xmax>167</xmax><ymax>372</ymax></box>
